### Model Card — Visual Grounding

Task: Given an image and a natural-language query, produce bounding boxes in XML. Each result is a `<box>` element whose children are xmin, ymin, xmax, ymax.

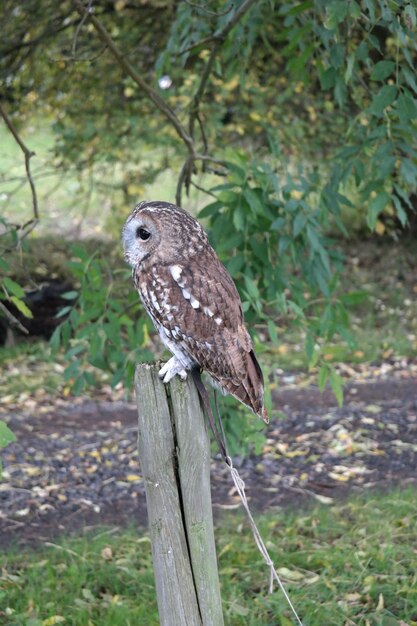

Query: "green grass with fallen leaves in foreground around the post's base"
<box><xmin>0</xmin><ymin>490</ymin><xmax>417</xmax><ymax>626</ymax></box>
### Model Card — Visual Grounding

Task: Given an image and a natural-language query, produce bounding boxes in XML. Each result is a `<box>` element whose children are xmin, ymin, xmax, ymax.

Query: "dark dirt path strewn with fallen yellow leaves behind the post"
<box><xmin>0</xmin><ymin>360</ymin><xmax>417</xmax><ymax>546</ymax></box>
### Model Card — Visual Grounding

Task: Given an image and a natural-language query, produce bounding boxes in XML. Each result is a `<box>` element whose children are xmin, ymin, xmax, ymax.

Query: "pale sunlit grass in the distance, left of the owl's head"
<box><xmin>0</xmin><ymin>119</ymin><xmax>213</xmax><ymax>239</ymax></box>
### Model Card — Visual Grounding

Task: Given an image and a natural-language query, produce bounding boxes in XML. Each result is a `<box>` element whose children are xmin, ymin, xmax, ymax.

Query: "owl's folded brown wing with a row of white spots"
<box><xmin>136</xmin><ymin>252</ymin><xmax>266</xmax><ymax>419</ymax></box>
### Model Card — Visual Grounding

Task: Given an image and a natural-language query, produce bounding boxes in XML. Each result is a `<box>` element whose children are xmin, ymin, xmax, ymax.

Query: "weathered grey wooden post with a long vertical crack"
<box><xmin>135</xmin><ymin>364</ymin><xmax>224</xmax><ymax>626</ymax></box>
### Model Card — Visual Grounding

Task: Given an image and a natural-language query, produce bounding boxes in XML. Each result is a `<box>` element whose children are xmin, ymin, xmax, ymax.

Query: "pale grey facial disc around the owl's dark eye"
<box><xmin>122</xmin><ymin>215</ymin><xmax>159</xmax><ymax>267</ymax></box>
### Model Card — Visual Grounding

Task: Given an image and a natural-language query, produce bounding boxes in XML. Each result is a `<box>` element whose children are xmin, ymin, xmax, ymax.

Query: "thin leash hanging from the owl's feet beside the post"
<box><xmin>192</xmin><ymin>369</ymin><xmax>303</xmax><ymax>626</ymax></box>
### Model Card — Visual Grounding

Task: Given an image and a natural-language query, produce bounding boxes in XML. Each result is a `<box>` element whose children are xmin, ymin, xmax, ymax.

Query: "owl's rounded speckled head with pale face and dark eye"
<box><xmin>122</xmin><ymin>201</ymin><xmax>208</xmax><ymax>267</ymax></box>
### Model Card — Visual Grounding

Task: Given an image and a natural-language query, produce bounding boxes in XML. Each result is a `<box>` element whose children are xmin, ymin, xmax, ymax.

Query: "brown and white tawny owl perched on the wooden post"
<box><xmin>122</xmin><ymin>201</ymin><xmax>269</xmax><ymax>423</ymax></box>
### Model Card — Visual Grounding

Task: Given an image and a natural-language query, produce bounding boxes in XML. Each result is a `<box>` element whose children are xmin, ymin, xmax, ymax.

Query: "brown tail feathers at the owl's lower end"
<box><xmin>219</xmin><ymin>350</ymin><xmax>269</xmax><ymax>424</ymax></box>
